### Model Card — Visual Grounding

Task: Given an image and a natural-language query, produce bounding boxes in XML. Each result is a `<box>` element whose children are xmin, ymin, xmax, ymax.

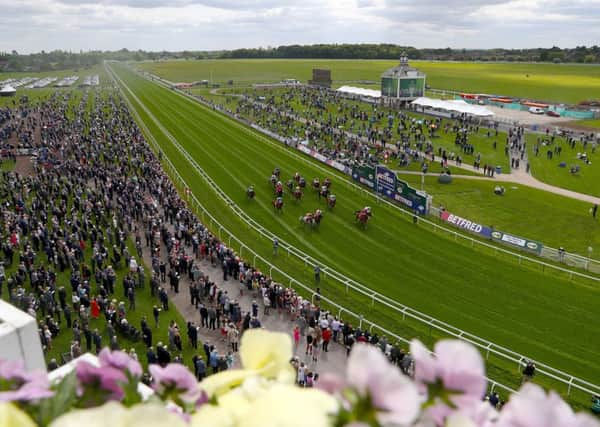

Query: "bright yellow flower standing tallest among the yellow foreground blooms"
<box><xmin>200</xmin><ymin>329</ymin><xmax>294</xmax><ymax>397</ymax></box>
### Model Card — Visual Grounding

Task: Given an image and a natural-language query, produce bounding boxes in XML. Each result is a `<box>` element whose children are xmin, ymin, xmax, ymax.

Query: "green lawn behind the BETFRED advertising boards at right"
<box><xmin>400</xmin><ymin>175</ymin><xmax>600</xmax><ymax>257</ymax></box>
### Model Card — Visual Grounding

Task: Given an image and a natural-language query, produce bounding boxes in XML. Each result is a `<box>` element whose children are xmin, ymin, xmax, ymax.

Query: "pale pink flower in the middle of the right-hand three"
<box><xmin>410</xmin><ymin>340</ymin><xmax>487</xmax><ymax>399</ymax></box>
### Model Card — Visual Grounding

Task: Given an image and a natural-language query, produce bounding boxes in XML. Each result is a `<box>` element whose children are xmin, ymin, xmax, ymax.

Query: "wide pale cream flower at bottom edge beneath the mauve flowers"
<box><xmin>50</xmin><ymin>402</ymin><xmax>186</xmax><ymax>427</ymax></box>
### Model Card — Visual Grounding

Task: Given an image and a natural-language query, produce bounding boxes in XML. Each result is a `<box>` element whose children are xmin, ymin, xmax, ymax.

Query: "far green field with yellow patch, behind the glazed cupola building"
<box><xmin>138</xmin><ymin>59</ymin><xmax>600</xmax><ymax>103</ymax></box>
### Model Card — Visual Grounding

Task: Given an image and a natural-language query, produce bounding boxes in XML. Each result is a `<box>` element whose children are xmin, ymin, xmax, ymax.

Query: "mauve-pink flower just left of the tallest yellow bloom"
<box><xmin>148</xmin><ymin>363</ymin><xmax>203</xmax><ymax>404</ymax></box>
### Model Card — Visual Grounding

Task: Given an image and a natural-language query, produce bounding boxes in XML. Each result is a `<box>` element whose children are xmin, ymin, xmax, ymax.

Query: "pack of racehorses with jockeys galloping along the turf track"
<box><xmin>246</xmin><ymin>168</ymin><xmax>371</xmax><ymax>227</ymax></box>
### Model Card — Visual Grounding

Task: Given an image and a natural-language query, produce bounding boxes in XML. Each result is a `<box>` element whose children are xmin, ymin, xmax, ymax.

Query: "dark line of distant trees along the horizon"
<box><xmin>0</xmin><ymin>43</ymin><xmax>600</xmax><ymax>71</ymax></box>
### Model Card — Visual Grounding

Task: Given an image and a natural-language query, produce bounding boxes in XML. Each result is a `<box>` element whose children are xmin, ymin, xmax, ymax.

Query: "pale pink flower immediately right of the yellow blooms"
<box><xmin>347</xmin><ymin>344</ymin><xmax>421</xmax><ymax>425</ymax></box>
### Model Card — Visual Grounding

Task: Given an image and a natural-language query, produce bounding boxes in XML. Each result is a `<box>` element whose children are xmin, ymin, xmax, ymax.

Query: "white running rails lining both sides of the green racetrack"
<box><xmin>111</xmin><ymin>61</ymin><xmax>600</xmax><ymax>402</ymax></box>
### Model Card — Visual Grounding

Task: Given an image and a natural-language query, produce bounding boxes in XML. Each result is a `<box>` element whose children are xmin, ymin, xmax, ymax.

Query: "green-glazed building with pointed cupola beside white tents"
<box><xmin>381</xmin><ymin>53</ymin><xmax>426</xmax><ymax>102</ymax></box>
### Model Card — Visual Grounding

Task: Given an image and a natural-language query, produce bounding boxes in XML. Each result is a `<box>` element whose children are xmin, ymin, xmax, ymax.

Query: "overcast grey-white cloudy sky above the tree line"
<box><xmin>0</xmin><ymin>0</ymin><xmax>600</xmax><ymax>53</ymax></box>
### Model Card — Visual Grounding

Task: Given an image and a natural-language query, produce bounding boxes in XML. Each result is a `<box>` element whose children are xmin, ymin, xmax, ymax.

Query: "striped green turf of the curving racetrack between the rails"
<box><xmin>109</xmin><ymin>63</ymin><xmax>600</xmax><ymax>399</ymax></box>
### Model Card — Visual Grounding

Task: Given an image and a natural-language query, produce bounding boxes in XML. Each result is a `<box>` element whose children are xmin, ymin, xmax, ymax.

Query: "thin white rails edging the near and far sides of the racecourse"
<box><xmin>108</xmin><ymin>62</ymin><xmax>600</xmax><ymax>402</ymax></box>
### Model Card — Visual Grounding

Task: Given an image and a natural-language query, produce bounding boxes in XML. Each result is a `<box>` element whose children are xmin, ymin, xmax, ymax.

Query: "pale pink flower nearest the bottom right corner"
<box><xmin>496</xmin><ymin>383</ymin><xmax>600</xmax><ymax>427</ymax></box>
